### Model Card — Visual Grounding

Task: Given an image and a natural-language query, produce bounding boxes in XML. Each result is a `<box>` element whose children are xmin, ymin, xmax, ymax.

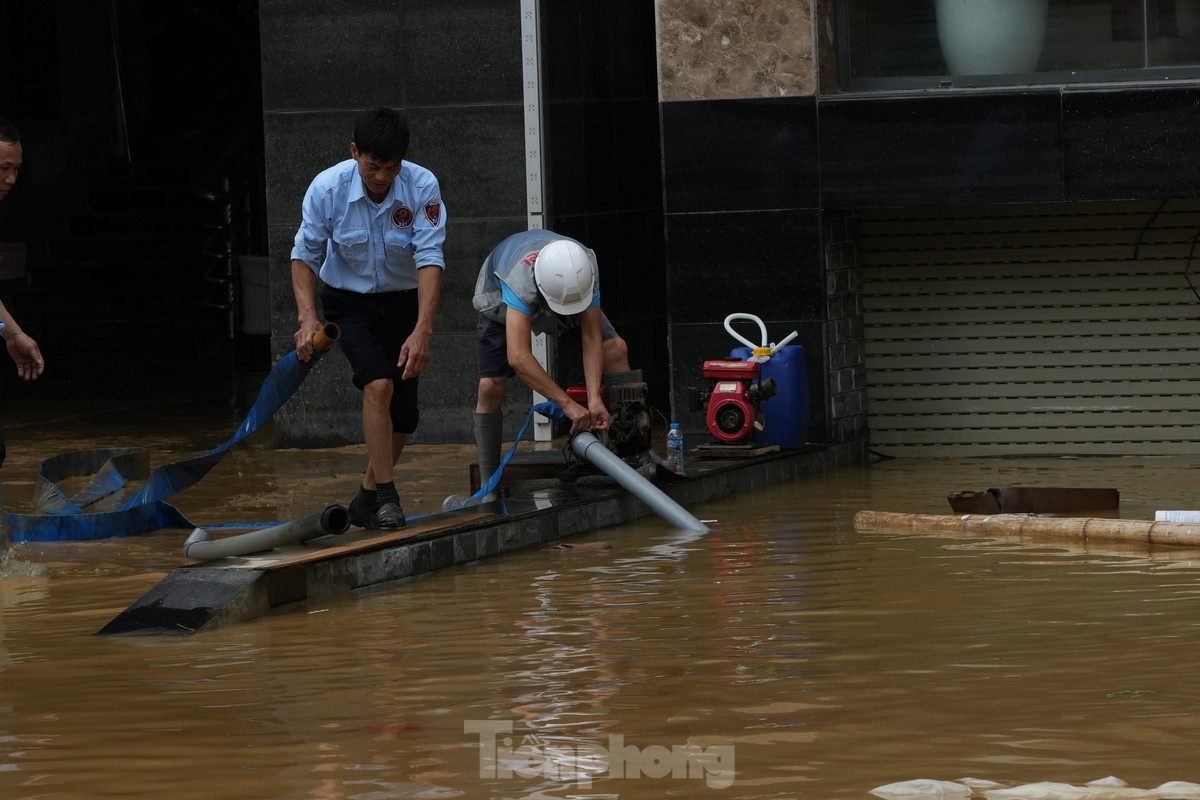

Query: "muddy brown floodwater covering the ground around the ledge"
<box><xmin>0</xmin><ymin>379</ymin><xmax>1200</xmax><ymax>800</ymax></box>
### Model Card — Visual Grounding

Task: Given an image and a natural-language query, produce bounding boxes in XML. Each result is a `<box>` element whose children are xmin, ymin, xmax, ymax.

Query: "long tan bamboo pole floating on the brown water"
<box><xmin>854</xmin><ymin>511</ymin><xmax>1200</xmax><ymax>547</ymax></box>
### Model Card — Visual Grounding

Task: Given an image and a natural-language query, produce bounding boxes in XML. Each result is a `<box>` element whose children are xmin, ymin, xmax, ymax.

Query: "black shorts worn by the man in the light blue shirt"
<box><xmin>320</xmin><ymin>285</ymin><xmax>420</xmax><ymax>434</ymax></box>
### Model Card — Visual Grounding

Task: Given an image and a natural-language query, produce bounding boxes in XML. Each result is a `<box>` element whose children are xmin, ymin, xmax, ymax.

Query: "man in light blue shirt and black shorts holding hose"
<box><xmin>292</xmin><ymin>108</ymin><xmax>446</xmax><ymax>529</ymax></box>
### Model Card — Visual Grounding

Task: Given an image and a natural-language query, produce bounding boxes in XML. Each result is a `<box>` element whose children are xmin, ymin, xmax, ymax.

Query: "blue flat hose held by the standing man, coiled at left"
<box><xmin>4</xmin><ymin>325</ymin><xmax>338</xmax><ymax>542</ymax></box>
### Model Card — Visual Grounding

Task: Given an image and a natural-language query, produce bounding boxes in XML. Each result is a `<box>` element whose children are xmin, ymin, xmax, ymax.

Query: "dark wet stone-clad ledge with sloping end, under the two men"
<box><xmin>98</xmin><ymin>443</ymin><xmax>866</xmax><ymax>636</ymax></box>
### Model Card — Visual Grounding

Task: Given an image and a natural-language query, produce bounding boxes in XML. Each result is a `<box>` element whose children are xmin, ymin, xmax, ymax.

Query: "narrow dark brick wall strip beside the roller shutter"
<box><xmin>822</xmin><ymin>211</ymin><xmax>868</xmax><ymax>447</ymax></box>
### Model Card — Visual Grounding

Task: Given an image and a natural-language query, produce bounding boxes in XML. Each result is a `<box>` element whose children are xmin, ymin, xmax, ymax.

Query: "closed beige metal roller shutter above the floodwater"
<box><xmin>859</xmin><ymin>199</ymin><xmax>1200</xmax><ymax>456</ymax></box>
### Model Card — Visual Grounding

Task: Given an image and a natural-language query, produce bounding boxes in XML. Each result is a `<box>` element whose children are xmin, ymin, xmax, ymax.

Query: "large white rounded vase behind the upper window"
<box><xmin>937</xmin><ymin>0</ymin><xmax>1049</xmax><ymax>76</ymax></box>
